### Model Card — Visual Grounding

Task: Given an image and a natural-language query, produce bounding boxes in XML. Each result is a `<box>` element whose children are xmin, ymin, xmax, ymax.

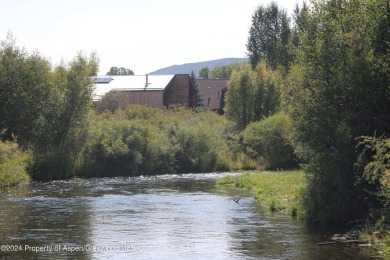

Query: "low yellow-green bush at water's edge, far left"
<box><xmin>0</xmin><ymin>141</ymin><xmax>30</xmax><ymax>188</ymax></box>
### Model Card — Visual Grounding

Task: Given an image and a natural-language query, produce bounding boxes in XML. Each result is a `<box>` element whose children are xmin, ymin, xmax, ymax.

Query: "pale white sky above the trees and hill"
<box><xmin>0</xmin><ymin>0</ymin><xmax>296</xmax><ymax>75</ymax></box>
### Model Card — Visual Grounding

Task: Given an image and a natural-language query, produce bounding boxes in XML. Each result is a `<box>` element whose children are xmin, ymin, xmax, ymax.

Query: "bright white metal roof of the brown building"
<box><xmin>93</xmin><ymin>75</ymin><xmax>175</xmax><ymax>100</ymax></box>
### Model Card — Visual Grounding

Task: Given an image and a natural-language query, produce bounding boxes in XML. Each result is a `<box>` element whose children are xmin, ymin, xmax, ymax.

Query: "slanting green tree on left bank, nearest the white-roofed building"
<box><xmin>29</xmin><ymin>53</ymin><xmax>98</xmax><ymax>180</ymax></box>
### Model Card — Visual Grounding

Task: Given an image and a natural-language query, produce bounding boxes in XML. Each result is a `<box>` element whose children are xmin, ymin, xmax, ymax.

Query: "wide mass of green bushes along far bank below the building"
<box><xmin>79</xmin><ymin>106</ymin><xmax>231</xmax><ymax>176</ymax></box>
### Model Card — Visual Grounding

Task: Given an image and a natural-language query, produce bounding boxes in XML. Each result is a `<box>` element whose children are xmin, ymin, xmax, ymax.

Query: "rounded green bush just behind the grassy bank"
<box><xmin>242</xmin><ymin>113</ymin><xmax>298</xmax><ymax>170</ymax></box>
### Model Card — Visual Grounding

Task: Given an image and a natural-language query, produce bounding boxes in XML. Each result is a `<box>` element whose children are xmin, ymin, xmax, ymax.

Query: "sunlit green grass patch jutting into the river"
<box><xmin>217</xmin><ymin>171</ymin><xmax>306</xmax><ymax>217</ymax></box>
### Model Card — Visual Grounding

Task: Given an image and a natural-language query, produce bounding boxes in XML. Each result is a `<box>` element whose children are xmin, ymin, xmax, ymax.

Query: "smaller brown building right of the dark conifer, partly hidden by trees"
<box><xmin>197</xmin><ymin>79</ymin><xmax>229</xmax><ymax>114</ymax></box>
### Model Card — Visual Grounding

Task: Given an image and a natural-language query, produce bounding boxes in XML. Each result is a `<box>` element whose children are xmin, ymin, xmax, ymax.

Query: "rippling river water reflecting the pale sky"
<box><xmin>0</xmin><ymin>173</ymin><xmax>372</xmax><ymax>259</ymax></box>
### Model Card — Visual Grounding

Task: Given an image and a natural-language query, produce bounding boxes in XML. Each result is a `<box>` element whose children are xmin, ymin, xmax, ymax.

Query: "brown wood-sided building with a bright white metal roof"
<box><xmin>93</xmin><ymin>74</ymin><xmax>195</xmax><ymax>108</ymax></box>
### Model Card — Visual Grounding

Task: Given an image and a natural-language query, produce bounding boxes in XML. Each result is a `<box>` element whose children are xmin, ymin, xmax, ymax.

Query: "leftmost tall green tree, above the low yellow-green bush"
<box><xmin>0</xmin><ymin>34</ymin><xmax>51</xmax><ymax>148</ymax></box>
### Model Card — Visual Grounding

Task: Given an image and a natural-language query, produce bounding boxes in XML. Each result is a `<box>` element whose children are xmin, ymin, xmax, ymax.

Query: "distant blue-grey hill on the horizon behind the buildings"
<box><xmin>149</xmin><ymin>58</ymin><xmax>248</xmax><ymax>77</ymax></box>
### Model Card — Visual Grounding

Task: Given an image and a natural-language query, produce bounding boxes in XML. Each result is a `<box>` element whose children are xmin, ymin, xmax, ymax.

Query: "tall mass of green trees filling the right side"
<box><xmin>226</xmin><ymin>0</ymin><xmax>390</xmax><ymax>228</ymax></box>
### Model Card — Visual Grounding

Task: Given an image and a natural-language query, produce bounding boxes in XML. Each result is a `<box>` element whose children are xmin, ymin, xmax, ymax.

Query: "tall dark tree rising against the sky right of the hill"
<box><xmin>246</xmin><ymin>2</ymin><xmax>291</xmax><ymax>70</ymax></box>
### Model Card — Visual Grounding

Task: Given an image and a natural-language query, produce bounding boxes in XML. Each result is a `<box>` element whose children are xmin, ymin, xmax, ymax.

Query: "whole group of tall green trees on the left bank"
<box><xmin>0</xmin><ymin>34</ymin><xmax>99</xmax><ymax>179</ymax></box>
